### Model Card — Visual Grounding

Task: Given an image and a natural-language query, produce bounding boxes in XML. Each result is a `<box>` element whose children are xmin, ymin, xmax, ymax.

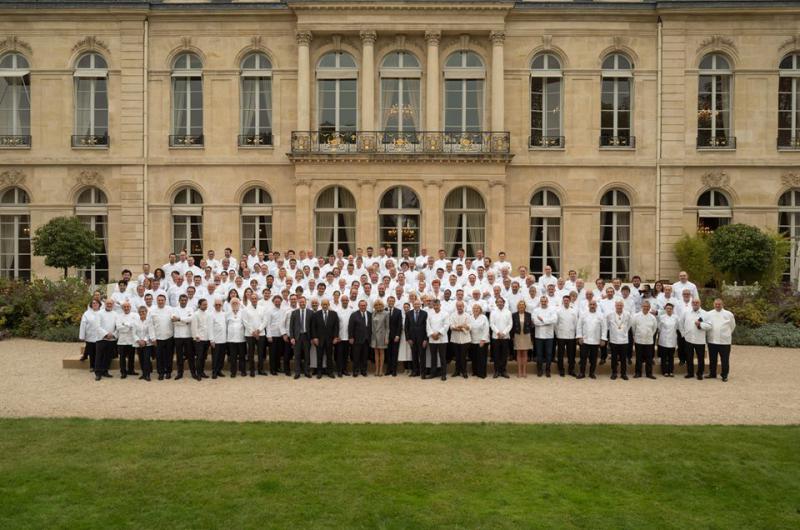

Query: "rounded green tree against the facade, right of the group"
<box><xmin>708</xmin><ymin>224</ymin><xmax>775</xmax><ymax>282</ymax></box>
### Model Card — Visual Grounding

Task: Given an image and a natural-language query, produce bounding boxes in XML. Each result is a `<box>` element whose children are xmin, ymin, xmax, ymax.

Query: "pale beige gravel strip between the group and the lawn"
<box><xmin>0</xmin><ymin>339</ymin><xmax>800</xmax><ymax>424</ymax></box>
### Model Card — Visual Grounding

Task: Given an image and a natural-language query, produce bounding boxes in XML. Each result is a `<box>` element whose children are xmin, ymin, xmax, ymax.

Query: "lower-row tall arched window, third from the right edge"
<box><xmin>600</xmin><ymin>189</ymin><xmax>631</xmax><ymax>279</ymax></box>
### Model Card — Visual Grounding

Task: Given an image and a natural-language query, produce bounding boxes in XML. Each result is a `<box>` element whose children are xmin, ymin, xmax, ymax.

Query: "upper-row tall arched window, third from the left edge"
<box><xmin>169</xmin><ymin>52</ymin><xmax>203</xmax><ymax>147</ymax></box>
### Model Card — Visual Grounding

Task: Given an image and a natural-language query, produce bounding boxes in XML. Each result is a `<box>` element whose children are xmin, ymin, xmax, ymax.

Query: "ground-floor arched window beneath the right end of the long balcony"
<box><xmin>444</xmin><ymin>186</ymin><xmax>486</xmax><ymax>258</ymax></box>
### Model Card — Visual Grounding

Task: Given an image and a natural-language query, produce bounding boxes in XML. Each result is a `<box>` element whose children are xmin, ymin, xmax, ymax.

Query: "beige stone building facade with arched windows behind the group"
<box><xmin>0</xmin><ymin>0</ymin><xmax>800</xmax><ymax>281</ymax></box>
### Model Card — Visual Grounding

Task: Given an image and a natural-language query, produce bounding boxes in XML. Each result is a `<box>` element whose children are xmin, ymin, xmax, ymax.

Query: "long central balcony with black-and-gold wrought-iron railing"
<box><xmin>289</xmin><ymin>131</ymin><xmax>512</xmax><ymax>162</ymax></box>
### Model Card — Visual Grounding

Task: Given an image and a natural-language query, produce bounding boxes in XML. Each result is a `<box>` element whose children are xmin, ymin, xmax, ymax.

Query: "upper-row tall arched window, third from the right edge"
<box><xmin>600</xmin><ymin>53</ymin><xmax>636</xmax><ymax>147</ymax></box>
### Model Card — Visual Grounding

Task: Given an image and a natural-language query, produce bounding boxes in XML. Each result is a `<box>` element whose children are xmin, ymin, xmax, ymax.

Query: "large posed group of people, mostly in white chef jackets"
<box><xmin>80</xmin><ymin>247</ymin><xmax>736</xmax><ymax>381</ymax></box>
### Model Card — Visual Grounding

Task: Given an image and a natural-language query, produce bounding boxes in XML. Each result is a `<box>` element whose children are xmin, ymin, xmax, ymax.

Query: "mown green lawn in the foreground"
<box><xmin>0</xmin><ymin>418</ymin><xmax>800</xmax><ymax>529</ymax></box>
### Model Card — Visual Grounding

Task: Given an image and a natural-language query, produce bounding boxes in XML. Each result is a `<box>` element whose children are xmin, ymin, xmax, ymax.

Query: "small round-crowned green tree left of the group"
<box><xmin>33</xmin><ymin>217</ymin><xmax>103</xmax><ymax>278</ymax></box>
